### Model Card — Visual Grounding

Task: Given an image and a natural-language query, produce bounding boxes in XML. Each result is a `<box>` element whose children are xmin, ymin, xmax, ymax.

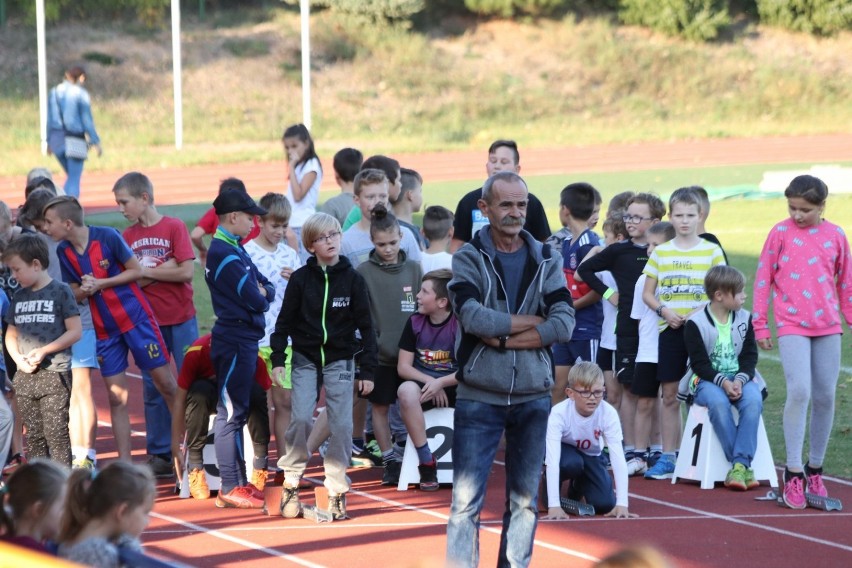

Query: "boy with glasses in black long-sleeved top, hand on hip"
<box><xmin>577</xmin><ymin>193</ymin><xmax>666</xmax><ymax>475</ymax></box>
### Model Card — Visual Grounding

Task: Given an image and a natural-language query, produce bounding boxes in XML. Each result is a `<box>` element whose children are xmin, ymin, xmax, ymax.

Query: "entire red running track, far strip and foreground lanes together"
<box><xmin>6</xmin><ymin>135</ymin><xmax>852</xmax><ymax>568</ymax></box>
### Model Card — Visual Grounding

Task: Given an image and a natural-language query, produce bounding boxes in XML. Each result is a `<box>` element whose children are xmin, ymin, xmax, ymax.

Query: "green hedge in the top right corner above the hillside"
<box><xmin>757</xmin><ymin>0</ymin><xmax>852</xmax><ymax>35</ymax></box>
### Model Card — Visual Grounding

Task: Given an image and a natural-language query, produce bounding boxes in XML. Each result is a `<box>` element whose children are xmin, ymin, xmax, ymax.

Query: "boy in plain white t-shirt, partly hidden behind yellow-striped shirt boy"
<box><xmin>627</xmin><ymin>221</ymin><xmax>675</xmax><ymax>475</ymax></box>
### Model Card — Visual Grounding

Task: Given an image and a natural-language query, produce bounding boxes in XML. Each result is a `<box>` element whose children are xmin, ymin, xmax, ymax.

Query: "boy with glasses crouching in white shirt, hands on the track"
<box><xmin>545</xmin><ymin>361</ymin><xmax>637</xmax><ymax>519</ymax></box>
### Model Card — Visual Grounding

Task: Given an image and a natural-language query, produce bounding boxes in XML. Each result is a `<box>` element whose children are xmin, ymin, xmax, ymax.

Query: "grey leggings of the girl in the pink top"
<box><xmin>778</xmin><ymin>334</ymin><xmax>841</xmax><ymax>470</ymax></box>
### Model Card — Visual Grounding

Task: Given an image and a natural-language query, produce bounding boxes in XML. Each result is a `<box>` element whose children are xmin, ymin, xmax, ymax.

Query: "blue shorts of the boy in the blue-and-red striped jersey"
<box><xmin>98</xmin><ymin>321</ymin><xmax>169</xmax><ymax>377</ymax></box>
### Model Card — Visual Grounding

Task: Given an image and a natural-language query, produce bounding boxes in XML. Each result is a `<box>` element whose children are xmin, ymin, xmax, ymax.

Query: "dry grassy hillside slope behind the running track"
<box><xmin>0</xmin><ymin>2</ymin><xmax>852</xmax><ymax>175</ymax></box>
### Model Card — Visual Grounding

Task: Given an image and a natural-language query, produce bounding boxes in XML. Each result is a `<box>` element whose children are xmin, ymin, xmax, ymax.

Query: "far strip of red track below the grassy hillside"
<box><xmin>0</xmin><ymin>134</ymin><xmax>852</xmax><ymax>209</ymax></box>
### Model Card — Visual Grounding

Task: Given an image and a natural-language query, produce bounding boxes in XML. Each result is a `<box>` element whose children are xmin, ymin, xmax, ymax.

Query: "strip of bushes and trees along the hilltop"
<box><xmin>6</xmin><ymin>0</ymin><xmax>852</xmax><ymax>41</ymax></box>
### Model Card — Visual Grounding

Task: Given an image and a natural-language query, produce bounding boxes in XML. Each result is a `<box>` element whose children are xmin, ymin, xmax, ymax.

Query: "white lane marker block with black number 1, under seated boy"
<box><xmin>672</xmin><ymin>404</ymin><xmax>778</xmax><ymax>489</ymax></box>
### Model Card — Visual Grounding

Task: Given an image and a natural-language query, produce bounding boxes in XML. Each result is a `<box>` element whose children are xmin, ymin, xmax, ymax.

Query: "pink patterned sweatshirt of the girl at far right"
<box><xmin>752</xmin><ymin>219</ymin><xmax>852</xmax><ymax>340</ymax></box>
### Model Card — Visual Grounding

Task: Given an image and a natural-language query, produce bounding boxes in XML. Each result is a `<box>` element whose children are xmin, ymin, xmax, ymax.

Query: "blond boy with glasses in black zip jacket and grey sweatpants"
<box><xmin>270</xmin><ymin>212</ymin><xmax>384</xmax><ymax>520</ymax></box>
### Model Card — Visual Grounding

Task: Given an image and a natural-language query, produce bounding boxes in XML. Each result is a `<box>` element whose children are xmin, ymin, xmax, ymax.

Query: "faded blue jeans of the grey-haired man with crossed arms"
<box><xmin>447</xmin><ymin>395</ymin><xmax>550</xmax><ymax>567</ymax></box>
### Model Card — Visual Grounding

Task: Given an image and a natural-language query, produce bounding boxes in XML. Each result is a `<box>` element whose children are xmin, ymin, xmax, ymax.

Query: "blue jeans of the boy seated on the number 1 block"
<box><xmin>695</xmin><ymin>381</ymin><xmax>763</xmax><ymax>467</ymax></box>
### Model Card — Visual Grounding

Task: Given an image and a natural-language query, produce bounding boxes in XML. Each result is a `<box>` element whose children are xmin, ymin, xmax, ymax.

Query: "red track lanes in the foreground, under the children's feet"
<box><xmin>94</xmin><ymin>366</ymin><xmax>852</xmax><ymax>568</ymax></box>
